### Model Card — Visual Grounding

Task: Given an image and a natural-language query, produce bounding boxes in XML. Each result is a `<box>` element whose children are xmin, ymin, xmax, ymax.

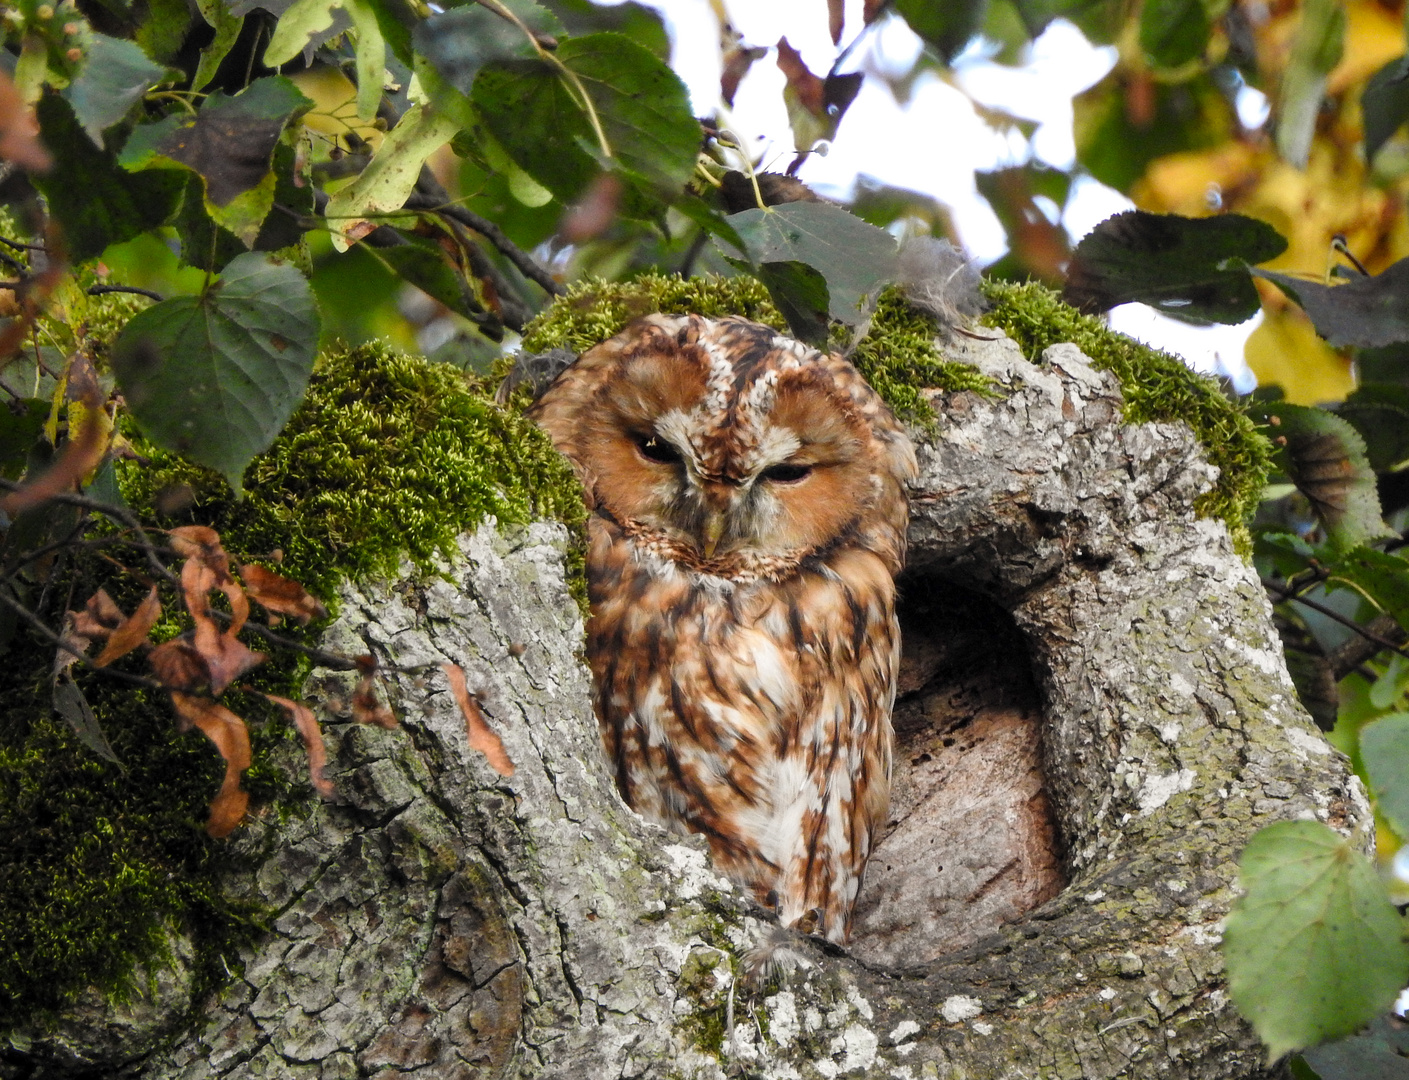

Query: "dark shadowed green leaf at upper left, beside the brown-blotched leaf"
<box><xmin>31</xmin><ymin>90</ymin><xmax>185</xmax><ymax>263</ymax></box>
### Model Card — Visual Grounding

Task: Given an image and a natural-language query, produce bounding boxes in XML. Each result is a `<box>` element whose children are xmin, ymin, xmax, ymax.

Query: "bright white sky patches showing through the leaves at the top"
<box><xmin>622</xmin><ymin>0</ymin><xmax>1262</xmax><ymax>390</ymax></box>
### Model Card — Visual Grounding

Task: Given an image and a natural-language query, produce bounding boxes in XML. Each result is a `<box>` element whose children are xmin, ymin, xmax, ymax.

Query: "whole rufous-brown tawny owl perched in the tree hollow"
<box><xmin>533</xmin><ymin>315</ymin><xmax>916</xmax><ymax>942</ymax></box>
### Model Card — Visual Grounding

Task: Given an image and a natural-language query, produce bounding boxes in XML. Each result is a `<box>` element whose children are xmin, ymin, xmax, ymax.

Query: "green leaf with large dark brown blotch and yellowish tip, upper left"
<box><xmin>121</xmin><ymin>75</ymin><xmax>313</xmax><ymax>246</ymax></box>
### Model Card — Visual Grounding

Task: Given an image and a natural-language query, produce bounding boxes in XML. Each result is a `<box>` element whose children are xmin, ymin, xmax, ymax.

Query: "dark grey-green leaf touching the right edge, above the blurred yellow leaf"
<box><xmin>1253</xmin><ymin>259</ymin><xmax>1409</xmax><ymax>349</ymax></box>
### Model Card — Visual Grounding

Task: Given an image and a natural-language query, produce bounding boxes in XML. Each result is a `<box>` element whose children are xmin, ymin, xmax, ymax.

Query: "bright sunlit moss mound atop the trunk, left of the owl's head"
<box><xmin>112</xmin><ymin>345</ymin><xmax>586</xmax><ymax>598</ymax></box>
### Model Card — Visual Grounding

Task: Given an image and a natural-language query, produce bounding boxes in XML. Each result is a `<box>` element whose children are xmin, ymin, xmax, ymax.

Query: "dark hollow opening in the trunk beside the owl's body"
<box><xmin>851</xmin><ymin>573</ymin><xmax>1065</xmax><ymax>967</ymax></box>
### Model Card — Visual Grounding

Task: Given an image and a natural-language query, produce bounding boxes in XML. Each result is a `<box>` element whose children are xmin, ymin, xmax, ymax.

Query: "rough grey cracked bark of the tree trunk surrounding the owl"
<box><xmin>8</xmin><ymin>338</ymin><xmax>1370</xmax><ymax>1080</ymax></box>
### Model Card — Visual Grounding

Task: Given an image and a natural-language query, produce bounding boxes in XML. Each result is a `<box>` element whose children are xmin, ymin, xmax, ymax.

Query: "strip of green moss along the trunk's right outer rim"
<box><xmin>983</xmin><ymin>280</ymin><xmax>1271</xmax><ymax>556</ymax></box>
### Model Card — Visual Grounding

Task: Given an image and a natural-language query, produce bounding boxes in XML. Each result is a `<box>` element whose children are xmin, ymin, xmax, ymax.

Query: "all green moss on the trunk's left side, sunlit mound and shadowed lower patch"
<box><xmin>0</xmin><ymin>345</ymin><xmax>586</xmax><ymax>1029</ymax></box>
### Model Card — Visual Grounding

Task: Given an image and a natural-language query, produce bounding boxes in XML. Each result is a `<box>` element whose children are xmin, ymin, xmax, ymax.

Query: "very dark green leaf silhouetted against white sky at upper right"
<box><xmin>1062</xmin><ymin>210</ymin><xmax>1286</xmax><ymax>322</ymax></box>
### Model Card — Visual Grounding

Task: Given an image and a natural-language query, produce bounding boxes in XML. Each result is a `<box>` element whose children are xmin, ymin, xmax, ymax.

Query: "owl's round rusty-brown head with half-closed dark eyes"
<box><xmin>533</xmin><ymin>315</ymin><xmax>916</xmax><ymax>569</ymax></box>
